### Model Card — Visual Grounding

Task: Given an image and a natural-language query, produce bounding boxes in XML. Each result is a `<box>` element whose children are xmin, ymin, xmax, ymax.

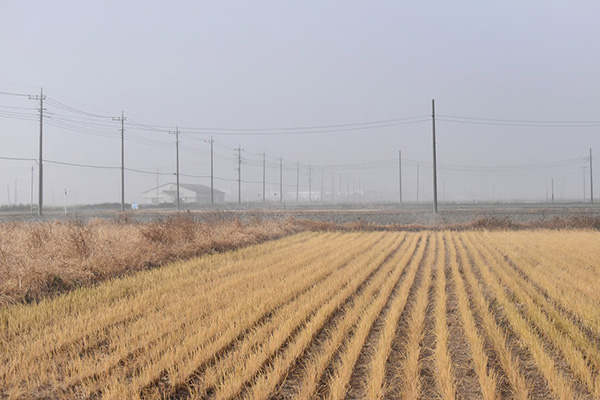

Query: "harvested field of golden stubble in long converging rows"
<box><xmin>0</xmin><ymin>230</ymin><xmax>600</xmax><ymax>399</ymax></box>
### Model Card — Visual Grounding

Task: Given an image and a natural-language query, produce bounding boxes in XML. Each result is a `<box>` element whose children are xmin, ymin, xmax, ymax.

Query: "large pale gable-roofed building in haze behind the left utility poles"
<box><xmin>144</xmin><ymin>182</ymin><xmax>225</xmax><ymax>205</ymax></box>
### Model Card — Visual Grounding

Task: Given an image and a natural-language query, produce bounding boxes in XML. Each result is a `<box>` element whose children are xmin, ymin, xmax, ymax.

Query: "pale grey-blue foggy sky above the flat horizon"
<box><xmin>0</xmin><ymin>0</ymin><xmax>600</xmax><ymax>206</ymax></box>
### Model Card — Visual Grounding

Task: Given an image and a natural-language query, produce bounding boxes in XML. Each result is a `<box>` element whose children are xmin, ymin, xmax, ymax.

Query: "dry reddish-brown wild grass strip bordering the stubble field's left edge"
<box><xmin>0</xmin><ymin>213</ymin><xmax>305</xmax><ymax>306</ymax></box>
